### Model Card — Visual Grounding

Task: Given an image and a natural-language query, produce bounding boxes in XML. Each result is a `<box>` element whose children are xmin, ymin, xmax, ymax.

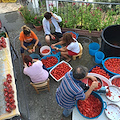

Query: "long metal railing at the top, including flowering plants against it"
<box><xmin>47</xmin><ymin>0</ymin><xmax>120</xmax><ymax>31</ymax></box>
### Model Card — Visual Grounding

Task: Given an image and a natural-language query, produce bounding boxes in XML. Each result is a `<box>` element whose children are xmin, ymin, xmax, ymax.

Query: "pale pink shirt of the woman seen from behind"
<box><xmin>23</xmin><ymin>60</ymin><xmax>49</xmax><ymax>83</ymax></box>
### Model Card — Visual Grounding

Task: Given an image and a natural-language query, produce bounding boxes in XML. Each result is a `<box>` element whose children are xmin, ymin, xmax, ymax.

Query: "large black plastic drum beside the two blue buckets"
<box><xmin>101</xmin><ymin>25</ymin><xmax>120</xmax><ymax>57</ymax></box>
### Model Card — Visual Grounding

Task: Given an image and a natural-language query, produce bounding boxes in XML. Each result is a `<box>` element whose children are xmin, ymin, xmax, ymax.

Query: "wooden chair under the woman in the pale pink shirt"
<box><xmin>30</xmin><ymin>78</ymin><xmax>50</xmax><ymax>94</ymax></box>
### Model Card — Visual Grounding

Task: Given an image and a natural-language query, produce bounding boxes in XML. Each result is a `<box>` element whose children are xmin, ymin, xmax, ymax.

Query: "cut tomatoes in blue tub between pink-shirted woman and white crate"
<box><xmin>41</xmin><ymin>56</ymin><xmax>58</xmax><ymax>68</ymax></box>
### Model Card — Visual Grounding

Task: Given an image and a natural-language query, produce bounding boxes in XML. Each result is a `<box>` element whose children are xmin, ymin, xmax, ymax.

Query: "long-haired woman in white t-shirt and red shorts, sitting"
<box><xmin>51</xmin><ymin>33</ymin><xmax>80</xmax><ymax>62</ymax></box>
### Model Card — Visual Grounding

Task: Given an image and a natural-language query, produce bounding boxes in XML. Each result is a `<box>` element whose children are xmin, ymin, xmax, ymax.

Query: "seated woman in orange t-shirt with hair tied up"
<box><xmin>19</xmin><ymin>25</ymin><xmax>41</xmax><ymax>61</ymax></box>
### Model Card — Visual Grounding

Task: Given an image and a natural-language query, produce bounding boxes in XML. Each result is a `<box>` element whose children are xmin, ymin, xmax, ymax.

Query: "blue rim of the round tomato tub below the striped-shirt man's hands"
<box><xmin>76</xmin><ymin>91</ymin><xmax>107</xmax><ymax>119</ymax></box>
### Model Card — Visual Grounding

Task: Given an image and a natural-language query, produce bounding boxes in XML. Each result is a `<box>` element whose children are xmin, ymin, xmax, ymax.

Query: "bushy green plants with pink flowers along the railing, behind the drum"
<box><xmin>58</xmin><ymin>3</ymin><xmax>120</xmax><ymax>32</ymax></box>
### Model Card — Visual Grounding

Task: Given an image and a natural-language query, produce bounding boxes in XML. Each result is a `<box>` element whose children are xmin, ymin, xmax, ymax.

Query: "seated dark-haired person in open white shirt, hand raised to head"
<box><xmin>43</xmin><ymin>12</ymin><xmax>62</xmax><ymax>46</ymax></box>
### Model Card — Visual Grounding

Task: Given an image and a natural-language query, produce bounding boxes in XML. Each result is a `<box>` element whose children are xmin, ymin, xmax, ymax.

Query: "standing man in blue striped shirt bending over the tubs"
<box><xmin>56</xmin><ymin>66</ymin><xmax>98</xmax><ymax>117</ymax></box>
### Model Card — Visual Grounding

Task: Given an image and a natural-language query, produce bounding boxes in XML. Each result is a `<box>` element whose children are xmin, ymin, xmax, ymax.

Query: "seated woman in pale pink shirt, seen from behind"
<box><xmin>23</xmin><ymin>55</ymin><xmax>49</xmax><ymax>83</ymax></box>
